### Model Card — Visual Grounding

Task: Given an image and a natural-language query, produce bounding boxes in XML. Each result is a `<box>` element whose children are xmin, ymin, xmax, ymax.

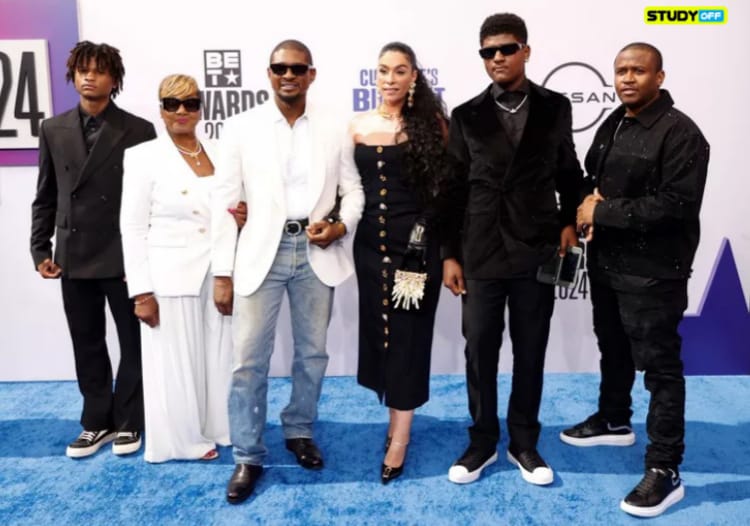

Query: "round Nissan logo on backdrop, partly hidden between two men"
<box><xmin>542</xmin><ymin>62</ymin><xmax>619</xmax><ymax>133</ymax></box>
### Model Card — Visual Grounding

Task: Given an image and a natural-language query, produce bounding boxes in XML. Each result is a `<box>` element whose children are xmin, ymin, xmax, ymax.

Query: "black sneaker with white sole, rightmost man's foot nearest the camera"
<box><xmin>620</xmin><ymin>468</ymin><xmax>685</xmax><ymax>517</ymax></box>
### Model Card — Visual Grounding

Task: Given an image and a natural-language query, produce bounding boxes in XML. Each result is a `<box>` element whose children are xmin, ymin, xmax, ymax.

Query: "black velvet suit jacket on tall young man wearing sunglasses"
<box><xmin>442</xmin><ymin>82</ymin><xmax>582</xmax><ymax>279</ymax></box>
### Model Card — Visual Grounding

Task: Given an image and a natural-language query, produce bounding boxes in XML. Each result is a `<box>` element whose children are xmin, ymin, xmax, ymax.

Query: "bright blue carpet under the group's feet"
<box><xmin>0</xmin><ymin>374</ymin><xmax>750</xmax><ymax>525</ymax></box>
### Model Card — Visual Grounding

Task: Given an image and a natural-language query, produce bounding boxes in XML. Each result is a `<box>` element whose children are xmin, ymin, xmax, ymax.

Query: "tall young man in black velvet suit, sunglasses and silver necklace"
<box><xmin>443</xmin><ymin>14</ymin><xmax>582</xmax><ymax>484</ymax></box>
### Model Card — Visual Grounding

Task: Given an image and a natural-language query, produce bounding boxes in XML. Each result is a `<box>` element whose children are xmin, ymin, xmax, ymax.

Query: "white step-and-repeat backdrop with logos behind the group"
<box><xmin>0</xmin><ymin>0</ymin><xmax>750</xmax><ymax>380</ymax></box>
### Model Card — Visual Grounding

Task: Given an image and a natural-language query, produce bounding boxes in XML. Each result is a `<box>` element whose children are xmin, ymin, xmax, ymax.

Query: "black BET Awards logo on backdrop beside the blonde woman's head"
<box><xmin>201</xmin><ymin>49</ymin><xmax>269</xmax><ymax>139</ymax></box>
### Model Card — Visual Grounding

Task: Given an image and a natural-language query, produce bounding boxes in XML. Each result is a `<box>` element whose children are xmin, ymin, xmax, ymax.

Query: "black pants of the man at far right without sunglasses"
<box><xmin>591</xmin><ymin>276</ymin><xmax>687</xmax><ymax>469</ymax></box>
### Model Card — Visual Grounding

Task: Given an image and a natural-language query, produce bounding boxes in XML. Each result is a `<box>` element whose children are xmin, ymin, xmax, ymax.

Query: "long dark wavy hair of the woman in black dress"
<box><xmin>378</xmin><ymin>42</ymin><xmax>449</xmax><ymax>204</ymax></box>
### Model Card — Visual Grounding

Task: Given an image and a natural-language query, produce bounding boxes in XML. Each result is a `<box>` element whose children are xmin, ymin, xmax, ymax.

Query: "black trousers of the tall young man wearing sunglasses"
<box><xmin>462</xmin><ymin>277</ymin><xmax>554</xmax><ymax>451</ymax></box>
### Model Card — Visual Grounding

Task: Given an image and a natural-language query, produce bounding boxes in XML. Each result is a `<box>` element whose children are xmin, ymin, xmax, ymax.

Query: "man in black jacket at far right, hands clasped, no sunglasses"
<box><xmin>560</xmin><ymin>43</ymin><xmax>709</xmax><ymax>517</ymax></box>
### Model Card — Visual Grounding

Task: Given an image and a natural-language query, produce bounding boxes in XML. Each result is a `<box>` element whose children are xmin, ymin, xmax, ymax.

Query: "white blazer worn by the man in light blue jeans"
<box><xmin>212</xmin><ymin>99</ymin><xmax>365</xmax><ymax>296</ymax></box>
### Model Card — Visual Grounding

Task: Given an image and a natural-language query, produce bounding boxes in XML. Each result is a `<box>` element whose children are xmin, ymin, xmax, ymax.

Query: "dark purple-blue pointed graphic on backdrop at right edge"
<box><xmin>680</xmin><ymin>239</ymin><xmax>750</xmax><ymax>375</ymax></box>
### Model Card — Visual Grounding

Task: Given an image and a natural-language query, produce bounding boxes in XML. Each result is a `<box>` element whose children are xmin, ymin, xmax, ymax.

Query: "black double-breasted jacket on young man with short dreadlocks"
<box><xmin>31</xmin><ymin>102</ymin><xmax>156</xmax><ymax>279</ymax></box>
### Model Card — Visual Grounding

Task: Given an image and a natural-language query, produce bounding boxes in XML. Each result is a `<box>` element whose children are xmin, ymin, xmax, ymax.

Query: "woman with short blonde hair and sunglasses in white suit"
<box><xmin>120</xmin><ymin>75</ymin><xmax>238</xmax><ymax>462</ymax></box>
